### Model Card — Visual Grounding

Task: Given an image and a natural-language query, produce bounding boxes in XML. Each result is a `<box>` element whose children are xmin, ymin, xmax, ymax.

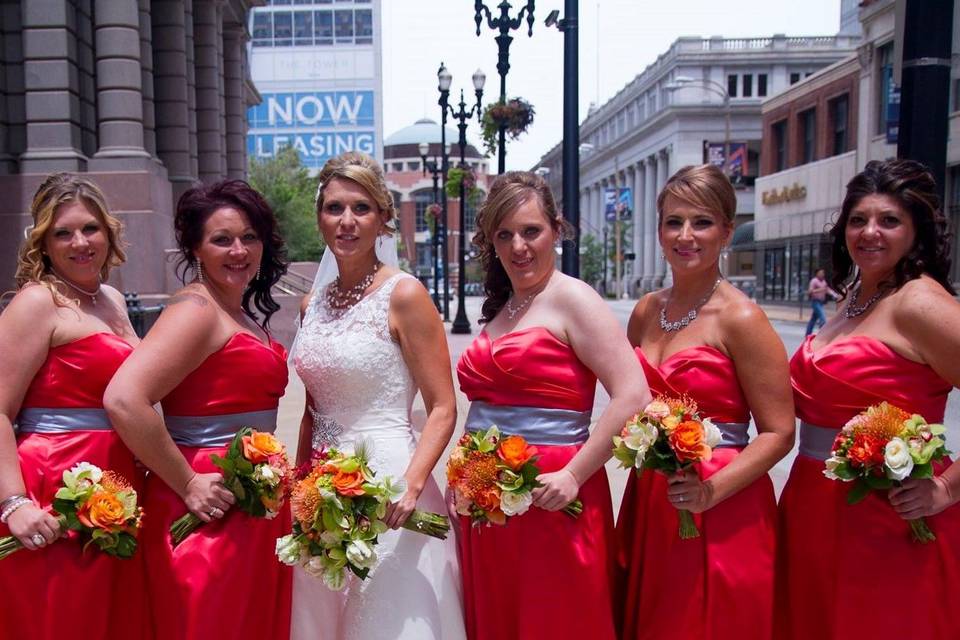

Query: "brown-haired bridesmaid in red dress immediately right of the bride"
<box><xmin>457</xmin><ymin>172</ymin><xmax>650</xmax><ymax>640</ymax></box>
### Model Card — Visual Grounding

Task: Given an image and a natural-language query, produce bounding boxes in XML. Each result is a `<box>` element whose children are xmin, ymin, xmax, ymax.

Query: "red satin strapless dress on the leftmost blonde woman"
<box><xmin>0</xmin><ymin>333</ymin><xmax>152</xmax><ymax>640</ymax></box>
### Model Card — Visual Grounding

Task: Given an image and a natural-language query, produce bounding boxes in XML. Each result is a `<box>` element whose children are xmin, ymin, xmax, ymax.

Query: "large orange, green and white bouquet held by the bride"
<box><xmin>276</xmin><ymin>441</ymin><xmax>450</xmax><ymax>591</ymax></box>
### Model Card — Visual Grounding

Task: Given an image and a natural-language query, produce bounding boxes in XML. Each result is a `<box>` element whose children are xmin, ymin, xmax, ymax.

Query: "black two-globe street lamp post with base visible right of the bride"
<box><xmin>437</xmin><ymin>65</ymin><xmax>487</xmax><ymax>333</ymax></box>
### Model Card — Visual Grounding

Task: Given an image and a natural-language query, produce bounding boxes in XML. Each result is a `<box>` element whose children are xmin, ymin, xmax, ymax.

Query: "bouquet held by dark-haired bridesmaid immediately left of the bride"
<box><xmin>170</xmin><ymin>427</ymin><xmax>291</xmax><ymax>546</ymax></box>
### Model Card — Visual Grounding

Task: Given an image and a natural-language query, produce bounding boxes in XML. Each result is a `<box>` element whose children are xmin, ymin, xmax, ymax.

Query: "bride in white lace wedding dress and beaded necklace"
<box><xmin>291</xmin><ymin>153</ymin><xmax>465</xmax><ymax>640</ymax></box>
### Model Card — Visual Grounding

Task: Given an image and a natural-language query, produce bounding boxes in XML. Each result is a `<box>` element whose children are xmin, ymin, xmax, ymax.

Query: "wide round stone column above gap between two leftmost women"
<box><xmin>91</xmin><ymin>0</ymin><xmax>150</xmax><ymax>170</ymax></box>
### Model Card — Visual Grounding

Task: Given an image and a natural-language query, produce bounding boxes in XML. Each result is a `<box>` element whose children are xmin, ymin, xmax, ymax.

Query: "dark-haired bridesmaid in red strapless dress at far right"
<box><xmin>776</xmin><ymin>160</ymin><xmax>960</xmax><ymax>640</ymax></box>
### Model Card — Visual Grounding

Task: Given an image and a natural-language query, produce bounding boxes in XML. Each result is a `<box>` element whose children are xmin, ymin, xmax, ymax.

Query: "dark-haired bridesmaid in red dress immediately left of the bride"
<box><xmin>104</xmin><ymin>181</ymin><xmax>292</xmax><ymax>640</ymax></box>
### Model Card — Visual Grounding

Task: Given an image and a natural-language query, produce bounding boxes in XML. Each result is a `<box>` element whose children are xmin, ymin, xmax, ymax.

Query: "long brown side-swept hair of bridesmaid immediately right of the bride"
<box><xmin>473</xmin><ymin>171</ymin><xmax>573</xmax><ymax>322</ymax></box>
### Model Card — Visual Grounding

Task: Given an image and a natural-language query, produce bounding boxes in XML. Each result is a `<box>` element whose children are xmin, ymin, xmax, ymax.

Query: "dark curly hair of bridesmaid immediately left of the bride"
<box><xmin>173</xmin><ymin>180</ymin><xmax>287</xmax><ymax>329</ymax></box>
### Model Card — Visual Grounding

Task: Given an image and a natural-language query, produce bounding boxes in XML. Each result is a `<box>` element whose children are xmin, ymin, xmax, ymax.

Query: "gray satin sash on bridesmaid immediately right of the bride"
<box><xmin>465</xmin><ymin>401</ymin><xmax>592</xmax><ymax>445</ymax></box>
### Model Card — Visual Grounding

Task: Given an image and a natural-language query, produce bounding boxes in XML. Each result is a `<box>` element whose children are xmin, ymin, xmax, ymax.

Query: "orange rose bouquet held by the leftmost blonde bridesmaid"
<box><xmin>0</xmin><ymin>462</ymin><xmax>143</xmax><ymax>559</ymax></box>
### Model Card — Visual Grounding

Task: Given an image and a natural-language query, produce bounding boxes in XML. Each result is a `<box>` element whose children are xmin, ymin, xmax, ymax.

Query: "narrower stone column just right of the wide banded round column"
<box><xmin>150</xmin><ymin>0</ymin><xmax>196</xmax><ymax>189</ymax></box>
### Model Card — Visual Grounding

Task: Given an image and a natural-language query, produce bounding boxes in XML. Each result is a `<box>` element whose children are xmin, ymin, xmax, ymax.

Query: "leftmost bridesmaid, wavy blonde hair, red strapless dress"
<box><xmin>0</xmin><ymin>174</ymin><xmax>152</xmax><ymax>640</ymax></box>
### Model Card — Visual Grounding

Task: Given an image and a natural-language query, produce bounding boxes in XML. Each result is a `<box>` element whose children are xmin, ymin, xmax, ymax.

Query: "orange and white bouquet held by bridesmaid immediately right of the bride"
<box><xmin>447</xmin><ymin>426</ymin><xmax>583</xmax><ymax>525</ymax></box>
